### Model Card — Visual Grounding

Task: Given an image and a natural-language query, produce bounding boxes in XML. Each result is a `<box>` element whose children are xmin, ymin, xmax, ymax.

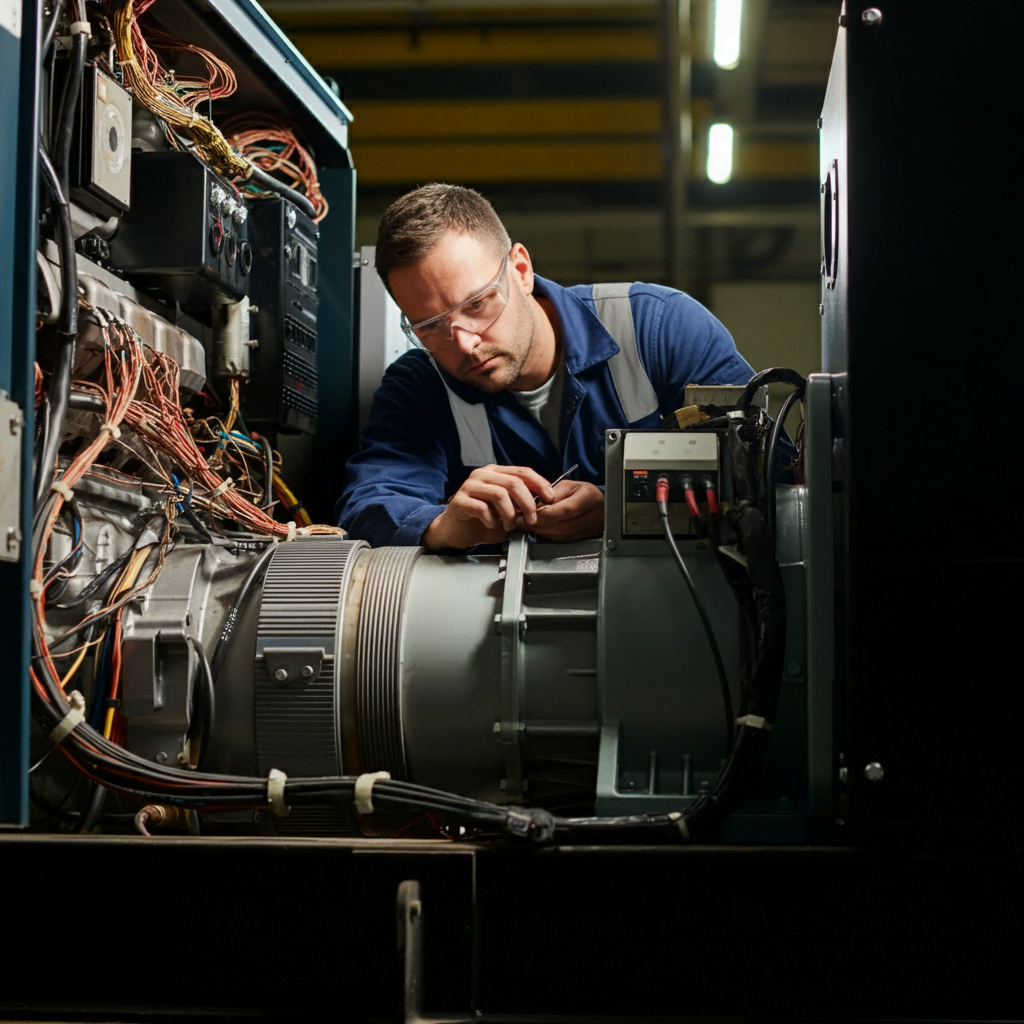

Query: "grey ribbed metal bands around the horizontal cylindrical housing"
<box><xmin>254</xmin><ymin>538</ymin><xmax>421</xmax><ymax>835</ymax></box>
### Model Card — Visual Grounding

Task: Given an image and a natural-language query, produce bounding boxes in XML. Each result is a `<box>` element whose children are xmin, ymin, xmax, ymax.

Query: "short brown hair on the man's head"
<box><xmin>374</xmin><ymin>181</ymin><xmax>512</xmax><ymax>292</ymax></box>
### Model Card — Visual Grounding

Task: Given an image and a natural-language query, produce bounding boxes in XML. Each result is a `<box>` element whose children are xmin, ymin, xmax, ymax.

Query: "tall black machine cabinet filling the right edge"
<box><xmin>820</xmin><ymin>0</ymin><xmax>1024</xmax><ymax>842</ymax></box>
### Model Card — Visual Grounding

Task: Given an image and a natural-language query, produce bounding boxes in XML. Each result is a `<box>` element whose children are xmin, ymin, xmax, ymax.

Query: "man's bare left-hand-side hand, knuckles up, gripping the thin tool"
<box><xmin>420</xmin><ymin>466</ymin><xmax>557</xmax><ymax>551</ymax></box>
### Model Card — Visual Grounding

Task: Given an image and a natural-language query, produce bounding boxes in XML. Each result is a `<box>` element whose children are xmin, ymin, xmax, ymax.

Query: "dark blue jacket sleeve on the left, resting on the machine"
<box><xmin>337</xmin><ymin>352</ymin><xmax>455</xmax><ymax>548</ymax></box>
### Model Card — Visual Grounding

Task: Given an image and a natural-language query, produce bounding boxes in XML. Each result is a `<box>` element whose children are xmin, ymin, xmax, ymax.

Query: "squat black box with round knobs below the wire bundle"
<box><xmin>110</xmin><ymin>153</ymin><xmax>253</xmax><ymax>311</ymax></box>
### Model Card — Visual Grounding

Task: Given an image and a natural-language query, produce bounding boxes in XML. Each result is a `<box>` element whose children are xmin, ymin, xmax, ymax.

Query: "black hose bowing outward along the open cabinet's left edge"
<box><xmin>35</xmin><ymin>142</ymin><xmax>78</xmax><ymax>509</ymax></box>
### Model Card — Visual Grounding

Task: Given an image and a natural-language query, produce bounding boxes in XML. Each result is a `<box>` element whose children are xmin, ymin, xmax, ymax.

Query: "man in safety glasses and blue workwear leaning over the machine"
<box><xmin>338</xmin><ymin>184</ymin><xmax>754</xmax><ymax>551</ymax></box>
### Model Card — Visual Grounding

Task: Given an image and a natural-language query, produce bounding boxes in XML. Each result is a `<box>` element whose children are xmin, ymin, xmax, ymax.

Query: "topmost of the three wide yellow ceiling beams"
<box><xmin>290</xmin><ymin>27</ymin><xmax>660</xmax><ymax>69</ymax></box>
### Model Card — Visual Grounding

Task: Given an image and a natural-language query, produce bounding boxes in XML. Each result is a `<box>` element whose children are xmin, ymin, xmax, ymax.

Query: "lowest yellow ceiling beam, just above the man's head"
<box><xmin>352</xmin><ymin>141</ymin><xmax>663</xmax><ymax>185</ymax></box>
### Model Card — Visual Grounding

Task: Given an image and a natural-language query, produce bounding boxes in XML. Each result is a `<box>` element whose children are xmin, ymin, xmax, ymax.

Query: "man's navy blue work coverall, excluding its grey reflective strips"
<box><xmin>337</xmin><ymin>278</ymin><xmax>754</xmax><ymax>547</ymax></box>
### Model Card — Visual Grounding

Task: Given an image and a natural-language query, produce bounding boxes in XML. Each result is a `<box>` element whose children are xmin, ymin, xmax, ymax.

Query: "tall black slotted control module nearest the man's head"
<box><xmin>243</xmin><ymin>199</ymin><xmax>319</xmax><ymax>434</ymax></box>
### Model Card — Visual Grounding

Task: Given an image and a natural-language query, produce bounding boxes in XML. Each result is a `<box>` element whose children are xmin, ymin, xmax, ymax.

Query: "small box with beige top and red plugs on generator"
<box><xmin>623</xmin><ymin>430</ymin><xmax>719</xmax><ymax>537</ymax></box>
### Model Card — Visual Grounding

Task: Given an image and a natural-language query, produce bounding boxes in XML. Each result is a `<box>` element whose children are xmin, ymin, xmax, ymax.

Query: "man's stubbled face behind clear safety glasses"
<box><xmin>389</xmin><ymin>231</ymin><xmax>536</xmax><ymax>393</ymax></box>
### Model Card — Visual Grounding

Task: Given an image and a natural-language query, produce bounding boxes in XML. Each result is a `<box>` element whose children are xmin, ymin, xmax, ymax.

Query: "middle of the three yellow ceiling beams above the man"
<box><xmin>351</xmin><ymin>99</ymin><xmax>662</xmax><ymax>138</ymax></box>
